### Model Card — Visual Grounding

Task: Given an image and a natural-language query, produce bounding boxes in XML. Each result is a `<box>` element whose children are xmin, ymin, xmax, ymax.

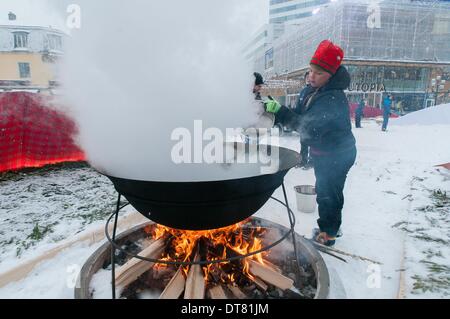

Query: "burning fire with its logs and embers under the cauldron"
<box><xmin>111</xmin><ymin>219</ymin><xmax>315</xmax><ymax>299</ymax></box>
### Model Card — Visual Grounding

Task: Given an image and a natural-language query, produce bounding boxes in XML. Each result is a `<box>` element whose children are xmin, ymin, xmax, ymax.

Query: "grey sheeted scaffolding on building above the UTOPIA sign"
<box><xmin>255</xmin><ymin>0</ymin><xmax>450</xmax><ymax>78</ymax></box>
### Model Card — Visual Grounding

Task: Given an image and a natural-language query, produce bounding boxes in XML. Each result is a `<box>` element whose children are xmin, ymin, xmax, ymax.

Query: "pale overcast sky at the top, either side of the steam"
<box><xmin>0</xmin><ymin>0</ymin><xmax>269</xmax><ymax>35</ymax></box>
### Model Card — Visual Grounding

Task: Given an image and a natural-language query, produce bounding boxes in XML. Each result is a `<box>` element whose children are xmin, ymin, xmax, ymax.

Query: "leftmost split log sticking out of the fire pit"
<box><xmin>116</xmin><ymin>238</ymin><xmax>165</xmax><ymax>287</ymax></box>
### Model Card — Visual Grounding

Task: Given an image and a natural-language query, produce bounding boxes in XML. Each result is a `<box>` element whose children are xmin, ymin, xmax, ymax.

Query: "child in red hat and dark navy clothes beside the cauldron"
<box><xmin>266</xmin><ymin>40</ymin><xmax>356</xmax><ymax>246</ymax></box>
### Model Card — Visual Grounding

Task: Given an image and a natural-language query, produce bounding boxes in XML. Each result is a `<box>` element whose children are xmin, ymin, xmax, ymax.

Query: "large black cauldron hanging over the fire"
<box><xmin>105</xmin><ymin>146</ymin><xmax>300</xmax><ymax>230</ymax></box>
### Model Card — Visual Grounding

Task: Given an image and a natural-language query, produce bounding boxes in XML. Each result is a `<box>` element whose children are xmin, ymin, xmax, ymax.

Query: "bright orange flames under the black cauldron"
<box><xmin>146</xmin><ymin>221</ymin><xmax>266</xmax><ymax>283</ymax></box>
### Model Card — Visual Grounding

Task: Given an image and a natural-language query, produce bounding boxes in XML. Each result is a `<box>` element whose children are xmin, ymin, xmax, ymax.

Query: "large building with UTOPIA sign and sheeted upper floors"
<box><xmin>254</xmin><ymin>0</ymin><xmax>450</xmax><ymax>112</ymax></box>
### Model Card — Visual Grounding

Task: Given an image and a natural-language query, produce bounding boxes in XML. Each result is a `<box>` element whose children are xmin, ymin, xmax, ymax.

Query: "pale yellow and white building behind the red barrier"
<box><xmin>0</xmin><ymin>25</ymin><xmax>66</xmax><ymax>91</ymax></box>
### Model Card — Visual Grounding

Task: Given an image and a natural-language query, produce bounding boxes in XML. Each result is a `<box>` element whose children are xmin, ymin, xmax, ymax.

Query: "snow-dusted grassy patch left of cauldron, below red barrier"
<box><xmin>0</xmin><ymin>165</ymin><xmax>117</xmax><ymax>273</ymax></box>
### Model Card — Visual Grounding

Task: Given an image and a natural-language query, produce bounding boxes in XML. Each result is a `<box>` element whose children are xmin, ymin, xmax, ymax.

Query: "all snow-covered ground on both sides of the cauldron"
<box><xmin>0</xmin><ymin>120</ymin><xmax>450</xmax><ymax>298</ymax></box>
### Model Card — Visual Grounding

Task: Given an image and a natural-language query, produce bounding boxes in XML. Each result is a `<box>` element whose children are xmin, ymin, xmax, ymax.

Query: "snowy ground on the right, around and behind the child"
<box><xmin>267</xmin><ymin>121</ymin><xmax>450</xmax><ymax>298</ymax></box>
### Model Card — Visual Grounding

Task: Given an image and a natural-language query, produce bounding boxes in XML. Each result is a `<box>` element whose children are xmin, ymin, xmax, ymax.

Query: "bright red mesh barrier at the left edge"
<box><xmin>0</xmin><ymin>92</ymin><xmax>85</xmax><ymax>172</ymax></box>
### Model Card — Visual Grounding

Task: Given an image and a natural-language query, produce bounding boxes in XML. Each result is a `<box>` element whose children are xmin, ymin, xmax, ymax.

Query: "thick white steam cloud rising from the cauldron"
<box><xmin>61</xmin><ymin>0</ymin><xmax>268</xmax><ymax>181</ymax></box>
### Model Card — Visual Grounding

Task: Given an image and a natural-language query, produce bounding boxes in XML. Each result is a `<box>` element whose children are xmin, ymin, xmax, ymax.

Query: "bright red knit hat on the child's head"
<box><xmin>311</xmin><ymin>40</ymin><xmax>344</xmax><ymax>74</ymax></box>
